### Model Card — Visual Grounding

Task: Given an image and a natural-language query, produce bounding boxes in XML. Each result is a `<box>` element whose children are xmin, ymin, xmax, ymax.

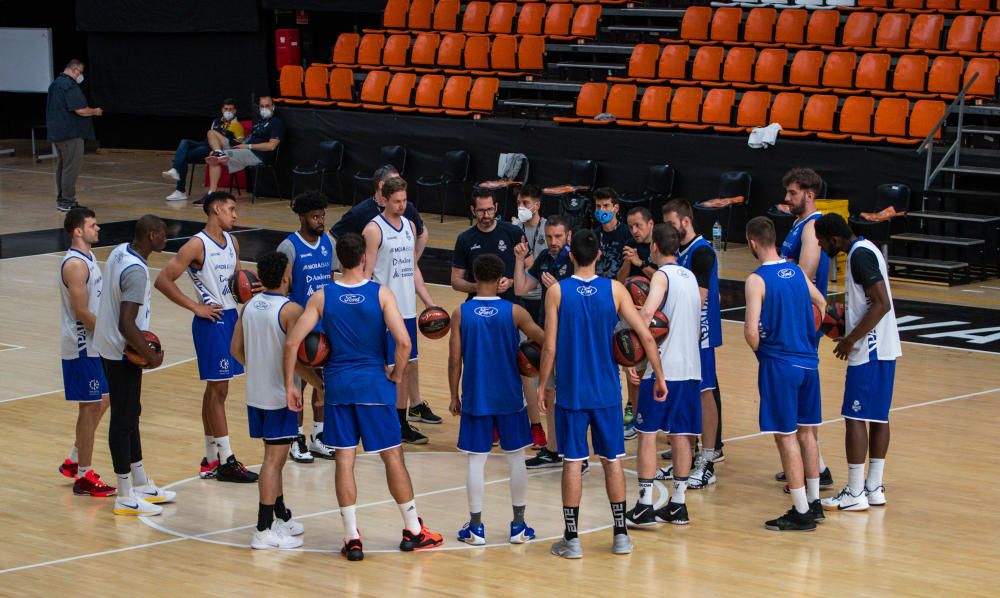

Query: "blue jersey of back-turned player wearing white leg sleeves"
<box><xmin>461</xmin><ymin>297</ymin><xmax>524</xmax><ymax>415</ymax></box>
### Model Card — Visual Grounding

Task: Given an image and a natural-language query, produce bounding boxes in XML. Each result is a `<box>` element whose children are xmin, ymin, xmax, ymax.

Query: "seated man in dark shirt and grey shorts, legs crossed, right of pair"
<box><xmin>194</xmin><ymin>96</ymin><xmax>285</xmax><ymax>205</ymax></box>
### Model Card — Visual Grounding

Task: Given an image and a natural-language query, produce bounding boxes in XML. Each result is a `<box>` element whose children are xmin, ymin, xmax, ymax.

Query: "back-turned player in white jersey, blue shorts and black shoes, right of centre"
<box><xmin>625</xmin><ymin>224</ymin><xmax>702</xmax><ymax>527</ymax></box>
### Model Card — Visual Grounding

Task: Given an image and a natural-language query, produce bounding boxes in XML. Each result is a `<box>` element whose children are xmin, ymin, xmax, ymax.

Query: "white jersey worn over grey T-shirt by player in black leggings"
<box><xmin>94</xmin><ymin>243</ymin><xmax>153</xmax><ymax>361</ymax></box>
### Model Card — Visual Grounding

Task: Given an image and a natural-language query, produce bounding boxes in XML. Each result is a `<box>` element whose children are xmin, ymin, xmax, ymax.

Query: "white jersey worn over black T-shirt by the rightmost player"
<box><xmin>844</xmin><ymin>239</ymin><xmax>903</xmax><ymax>365</ymax></box>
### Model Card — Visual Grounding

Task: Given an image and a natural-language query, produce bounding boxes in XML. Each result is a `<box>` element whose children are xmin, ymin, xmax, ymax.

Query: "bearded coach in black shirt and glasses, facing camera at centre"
<box><xmin>451</xmin><ymin>190</ymin><xmax>524</xmax><ymax>301</ymax></box>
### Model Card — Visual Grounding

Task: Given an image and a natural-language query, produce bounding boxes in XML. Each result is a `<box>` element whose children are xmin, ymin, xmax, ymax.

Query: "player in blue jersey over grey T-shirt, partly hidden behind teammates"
<box><xmin>278</xmin><ymin>191</ymin><xmax>333</xmax><ymax>463</ymax></box>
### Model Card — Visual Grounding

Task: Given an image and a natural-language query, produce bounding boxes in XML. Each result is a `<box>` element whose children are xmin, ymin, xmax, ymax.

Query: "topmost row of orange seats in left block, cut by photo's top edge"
<box><xmin>365</xmin><ymin>0</ymin><xmax>601</xmax><ymax>39</ymax></box>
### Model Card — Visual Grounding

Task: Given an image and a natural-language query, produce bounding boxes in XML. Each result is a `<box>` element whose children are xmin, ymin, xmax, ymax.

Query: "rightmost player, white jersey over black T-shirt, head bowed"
<box><xmin>816</xmin><ymin>214</ymin><xmax>903</xmax><ymax>511</ymax></box>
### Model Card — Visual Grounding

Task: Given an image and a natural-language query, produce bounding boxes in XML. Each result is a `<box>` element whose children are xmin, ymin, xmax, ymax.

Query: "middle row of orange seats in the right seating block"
<box><xmin>608</xmin><ymin>44</ymin><xmax>1000</xmax><ymax>99</ymax></box>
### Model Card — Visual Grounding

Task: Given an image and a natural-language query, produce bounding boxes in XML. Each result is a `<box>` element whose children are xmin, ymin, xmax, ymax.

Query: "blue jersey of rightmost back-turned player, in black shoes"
<box><xmin>754</xmin><ymin>262</ymin><xmax>819</xmax><ymax>369</ymax></box>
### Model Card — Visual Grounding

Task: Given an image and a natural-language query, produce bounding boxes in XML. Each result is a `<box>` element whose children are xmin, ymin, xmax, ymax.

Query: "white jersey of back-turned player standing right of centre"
<box><xmin>645</xmin><ymin>264</ymin><xmax>701</xmax><ymax>381</ymax></box>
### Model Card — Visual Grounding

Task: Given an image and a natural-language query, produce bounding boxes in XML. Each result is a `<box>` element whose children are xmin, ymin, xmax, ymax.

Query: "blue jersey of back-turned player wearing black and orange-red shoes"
<box><xmin>320</xmin><ymin>280</ymin><xmax>396</xmax><ymax>405</ymax></box>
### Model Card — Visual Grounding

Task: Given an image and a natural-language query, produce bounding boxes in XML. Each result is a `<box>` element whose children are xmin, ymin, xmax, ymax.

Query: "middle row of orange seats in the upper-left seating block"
<box><xmin>321</xmin><ymin>33</ymin><xmax>545</xmax><ymax>77</ymax></box>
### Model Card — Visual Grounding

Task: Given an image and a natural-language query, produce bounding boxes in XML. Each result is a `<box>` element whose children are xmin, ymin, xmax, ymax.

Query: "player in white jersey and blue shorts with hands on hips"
<box><xmin>156</xmin><ymin>192</ymin><xmax>257</xmax><ymax>483</ymax></box>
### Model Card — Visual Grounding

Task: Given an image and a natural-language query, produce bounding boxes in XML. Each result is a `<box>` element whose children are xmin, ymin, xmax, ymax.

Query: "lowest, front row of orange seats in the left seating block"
<box><xmin>275</xmin><ymin>65</ymin><xmax>500</xmax><ymax>116</ymax></box>
